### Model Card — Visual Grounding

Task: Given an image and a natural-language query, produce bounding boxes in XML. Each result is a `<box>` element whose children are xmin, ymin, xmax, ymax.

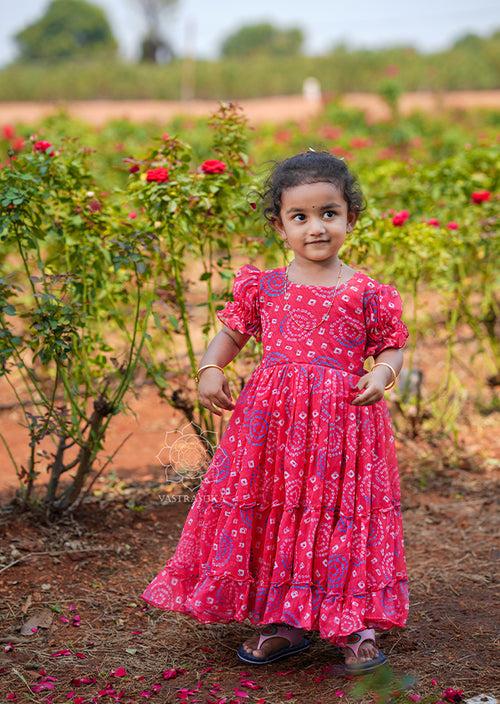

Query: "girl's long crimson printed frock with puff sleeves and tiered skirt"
<box><xmin>141</xmin><ymin>264</ymin><xmax>408</xmax><ymax>643</ymax></box>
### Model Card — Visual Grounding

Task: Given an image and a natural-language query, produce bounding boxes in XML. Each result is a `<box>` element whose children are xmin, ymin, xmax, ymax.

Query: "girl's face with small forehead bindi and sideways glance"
<box><xmin>274</xmin><ymin>181</ymin><xmax>356</xmax><ymax>261</ymax></box>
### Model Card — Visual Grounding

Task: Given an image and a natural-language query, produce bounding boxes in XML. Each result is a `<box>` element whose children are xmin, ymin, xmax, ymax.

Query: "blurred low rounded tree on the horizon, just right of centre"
<box><xmin>220</xmin><ymin>22</ymin><xmax>304</xmax><ymax>57</ymax></box>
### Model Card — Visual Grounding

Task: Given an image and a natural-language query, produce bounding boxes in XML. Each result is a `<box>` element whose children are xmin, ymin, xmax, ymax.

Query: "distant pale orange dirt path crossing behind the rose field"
<box><xmin>0</xmin><ymin>90</ymin><xmax>500</xmax><ymax>125</ymax></box>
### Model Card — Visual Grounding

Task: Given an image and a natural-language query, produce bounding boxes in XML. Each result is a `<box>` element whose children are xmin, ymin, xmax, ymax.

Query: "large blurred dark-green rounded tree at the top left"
<box><xmin>14</xmin><ymin>0</ymin><xmax>117</xmax><ymax>62</ymax></box>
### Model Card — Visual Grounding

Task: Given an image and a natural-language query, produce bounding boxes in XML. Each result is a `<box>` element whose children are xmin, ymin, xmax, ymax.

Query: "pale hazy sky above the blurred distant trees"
<box><xmin>0</xmin><ymin>0</ymin><xmax>500</xmax><ymax>65</ymax></box>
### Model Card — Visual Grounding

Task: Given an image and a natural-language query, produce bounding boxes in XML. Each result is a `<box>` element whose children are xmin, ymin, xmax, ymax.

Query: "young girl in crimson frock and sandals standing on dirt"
<box><xmin>142</xmin><ymin>151</ymin><xmax>408</xmax><ymax>674</ymax></box>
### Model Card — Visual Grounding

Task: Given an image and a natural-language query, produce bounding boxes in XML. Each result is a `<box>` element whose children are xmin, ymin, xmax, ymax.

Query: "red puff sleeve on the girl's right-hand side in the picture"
<box><xmin>363</xmin><ymin>284</ymin><xmax>409</xmax><ymax>357</ymax></box>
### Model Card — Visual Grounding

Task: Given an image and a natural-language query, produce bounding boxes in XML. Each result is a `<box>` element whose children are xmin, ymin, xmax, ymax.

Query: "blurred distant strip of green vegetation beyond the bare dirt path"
<box><xmin>0</xmin><ymin>33</ymin><xmax>500</xmax><ymax>101</ymax></box>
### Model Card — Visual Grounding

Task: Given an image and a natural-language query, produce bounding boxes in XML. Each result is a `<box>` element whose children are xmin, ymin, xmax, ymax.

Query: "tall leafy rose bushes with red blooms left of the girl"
<box><xmin>0</xmin><ymin>100</ymin><xmax>258</xmax><ymax>516</ymax></box>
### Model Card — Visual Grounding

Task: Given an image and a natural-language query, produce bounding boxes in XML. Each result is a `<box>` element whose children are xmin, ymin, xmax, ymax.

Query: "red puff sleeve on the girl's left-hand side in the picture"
<box><xmin>216</xmin><ymin>264</ymin><xmax>262</xmax><ymax>342</ymax></box>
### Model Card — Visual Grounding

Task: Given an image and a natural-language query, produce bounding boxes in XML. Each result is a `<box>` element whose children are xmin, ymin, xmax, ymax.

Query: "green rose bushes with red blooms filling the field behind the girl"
<box><xmin>0</xmin><ymin>102</ymin><xmax>500</xmax><ymax>507</ymax></box>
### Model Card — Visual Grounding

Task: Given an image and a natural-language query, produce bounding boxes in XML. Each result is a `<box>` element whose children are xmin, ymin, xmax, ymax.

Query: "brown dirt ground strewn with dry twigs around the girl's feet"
<box><xmin>0</xmin><ymin>441</ymin><xmax>498</xmax><ymax>704</ymax></box>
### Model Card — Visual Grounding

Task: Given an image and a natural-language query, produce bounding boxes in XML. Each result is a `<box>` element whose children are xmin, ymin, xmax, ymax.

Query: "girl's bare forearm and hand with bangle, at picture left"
<box><xmin>198</xmin><ymin>325</ymin><xmax>252</xmax><ymax>416</ymax></box>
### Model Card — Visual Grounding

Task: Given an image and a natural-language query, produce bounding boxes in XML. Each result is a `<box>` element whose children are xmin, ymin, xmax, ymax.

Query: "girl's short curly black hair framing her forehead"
<box><xmin>261</xmin><ymin>151</ymin><xmax>366</xmax><ymax>223</ymax></box>
